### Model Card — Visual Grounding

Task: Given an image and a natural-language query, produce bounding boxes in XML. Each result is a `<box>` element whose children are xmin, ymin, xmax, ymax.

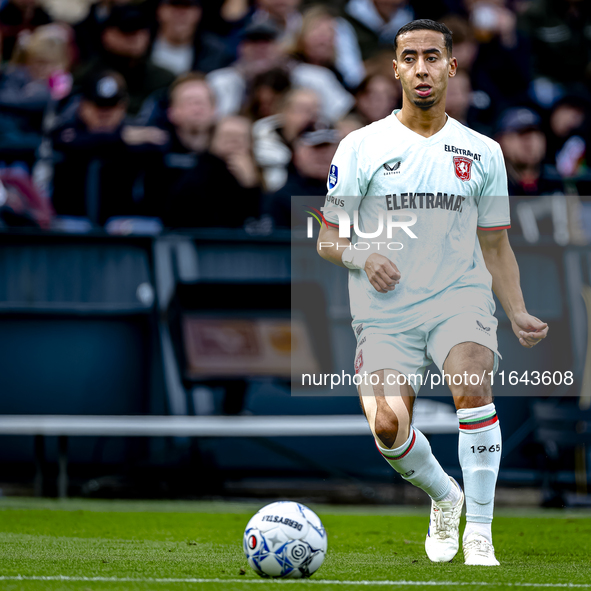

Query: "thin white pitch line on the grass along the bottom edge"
<box><xmin>0</xmin><ymin>575</ymin><xmax>591</xmax><ymax>589</ymax></box>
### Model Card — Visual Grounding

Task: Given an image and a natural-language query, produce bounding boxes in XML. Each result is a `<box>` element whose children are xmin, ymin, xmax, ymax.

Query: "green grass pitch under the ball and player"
<box><xmin>0</xmin><ymin>498</ymin><xmax>591</xmax><ymax>591</ymax></box>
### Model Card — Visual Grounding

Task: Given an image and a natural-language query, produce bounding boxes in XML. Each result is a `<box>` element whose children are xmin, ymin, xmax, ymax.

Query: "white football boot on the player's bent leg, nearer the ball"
<box><xmin>425</xmin><ymin>476</ymin><xmax>464</xmax><ymax>562</ymax></box>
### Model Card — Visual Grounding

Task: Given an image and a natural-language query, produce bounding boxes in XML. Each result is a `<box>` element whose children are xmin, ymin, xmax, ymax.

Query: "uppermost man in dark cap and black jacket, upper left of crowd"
<box><xmin>76</xmin><ymin>4</ymin><xmax>174</xmax><ymax>115</ymax></box>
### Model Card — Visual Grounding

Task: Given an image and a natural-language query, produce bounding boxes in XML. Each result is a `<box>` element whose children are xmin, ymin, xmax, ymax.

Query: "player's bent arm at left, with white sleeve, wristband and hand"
<box><xmin>317</xmin><ymin>136</ymin><xmax>400</xmax><ymax>293</ymax></box>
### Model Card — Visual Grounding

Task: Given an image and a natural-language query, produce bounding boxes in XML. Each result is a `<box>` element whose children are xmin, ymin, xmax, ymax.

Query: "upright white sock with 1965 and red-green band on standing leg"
<box><xmin>457</xmin><ymin>403</ymin><xmax>502</xmax><ymax>541</ymax></box>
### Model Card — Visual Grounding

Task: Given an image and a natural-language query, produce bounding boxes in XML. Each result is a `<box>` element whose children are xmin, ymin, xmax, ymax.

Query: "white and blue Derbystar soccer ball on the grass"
<box><xmin>244</xmin><ymin>501</ymin><xmax>326</xmax><ymax>579</ymax></box>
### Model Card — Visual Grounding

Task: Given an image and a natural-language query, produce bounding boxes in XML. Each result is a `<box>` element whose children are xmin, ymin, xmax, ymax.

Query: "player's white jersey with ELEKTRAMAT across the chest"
<box><xmin>324</xmin><ymin>111</ymin><xmax>510</xmax><ymax>334</ymax></box>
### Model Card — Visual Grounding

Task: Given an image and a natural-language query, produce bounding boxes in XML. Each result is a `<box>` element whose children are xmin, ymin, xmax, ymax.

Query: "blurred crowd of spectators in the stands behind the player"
<box><xmin>0</xmin><ymin>0</ymin><xmax>591</xmax><ymax>244</ymax></box>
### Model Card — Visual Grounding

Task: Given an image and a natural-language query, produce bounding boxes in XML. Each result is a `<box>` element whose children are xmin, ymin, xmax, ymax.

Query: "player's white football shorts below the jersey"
<box><xmin>355</xmin><ymin>312</ymin><xmax>500</xmax><ymax>394</ymax></box>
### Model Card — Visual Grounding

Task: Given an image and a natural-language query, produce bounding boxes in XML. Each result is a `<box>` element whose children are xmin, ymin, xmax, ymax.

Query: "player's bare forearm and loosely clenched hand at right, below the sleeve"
<box><xmin>478</xmin><ymin>230</ymin><xmax>548</xmax><ymax>349</ymax></box>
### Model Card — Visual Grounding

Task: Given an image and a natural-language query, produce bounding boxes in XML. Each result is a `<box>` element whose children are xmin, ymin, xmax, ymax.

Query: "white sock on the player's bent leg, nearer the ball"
<box><xmin>376</xmin><ymin>427</ymin><xmax>455</xmax><ymax>501</ymax></box>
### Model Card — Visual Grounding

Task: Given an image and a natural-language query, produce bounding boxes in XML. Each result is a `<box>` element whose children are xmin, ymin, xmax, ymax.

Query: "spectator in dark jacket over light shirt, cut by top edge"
<box><xmin>151</xmin><ymin>0</ymin><xmax>232</xmax><ymax>76</ymax></box>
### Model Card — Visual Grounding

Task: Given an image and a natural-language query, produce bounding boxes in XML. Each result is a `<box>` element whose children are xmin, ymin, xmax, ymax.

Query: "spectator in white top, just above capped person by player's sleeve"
<box><xmin>253</xmin><ymin>88</ymin><xmax>320</xmax><ymax>192</ymax></box>
